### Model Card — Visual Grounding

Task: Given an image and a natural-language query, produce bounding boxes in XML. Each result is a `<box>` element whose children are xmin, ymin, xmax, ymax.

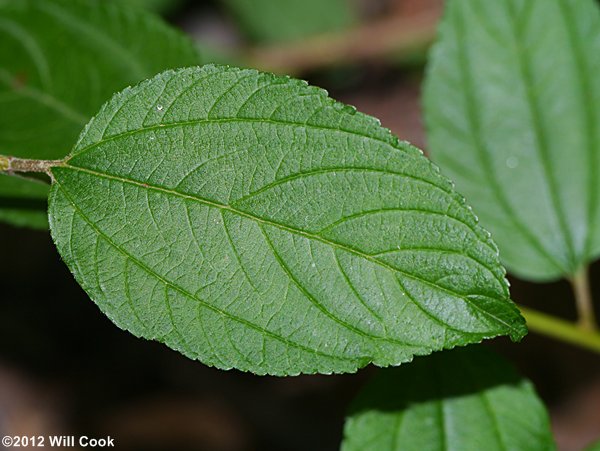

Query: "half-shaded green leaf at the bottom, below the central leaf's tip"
<box><xmin>342</xmin><ymin>346</ymin><xmax>556</xmax><ymax>451</ymax></box>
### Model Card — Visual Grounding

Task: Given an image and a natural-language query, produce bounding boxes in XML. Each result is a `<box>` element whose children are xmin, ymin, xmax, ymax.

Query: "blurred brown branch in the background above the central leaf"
<box><xmin>247</xmin><ymin>7</ymin><xmax>441</xmax><ymax>74</ymax></box>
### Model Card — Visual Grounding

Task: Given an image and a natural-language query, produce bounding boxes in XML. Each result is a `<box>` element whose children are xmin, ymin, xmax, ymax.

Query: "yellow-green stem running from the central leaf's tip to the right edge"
<box><xmin>519</xmin><ymin>306</ymin><xmax>600</xmax><ymax>353</ymax></box>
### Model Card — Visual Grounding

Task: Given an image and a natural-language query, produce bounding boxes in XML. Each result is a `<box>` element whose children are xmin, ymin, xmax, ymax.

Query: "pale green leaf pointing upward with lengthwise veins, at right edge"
<box><xmin>424</xmin><ymin>0</ymin><xmax>600</xmax><ymax>280</ymax></box>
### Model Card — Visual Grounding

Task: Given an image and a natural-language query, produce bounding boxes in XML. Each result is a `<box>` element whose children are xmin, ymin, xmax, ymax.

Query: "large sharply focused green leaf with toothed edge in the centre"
<box><xmin>50</xmin><ymin>66</ymin><xmax>526</xmax><ymax>375</ymax></box>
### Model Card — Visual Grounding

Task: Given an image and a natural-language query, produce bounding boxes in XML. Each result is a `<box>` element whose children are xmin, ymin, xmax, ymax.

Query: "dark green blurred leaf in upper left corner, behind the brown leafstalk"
<box><xmin>0</xmin><ymin>0</ymin><xmax>198</xmax><ymax>227</ymax></box>
